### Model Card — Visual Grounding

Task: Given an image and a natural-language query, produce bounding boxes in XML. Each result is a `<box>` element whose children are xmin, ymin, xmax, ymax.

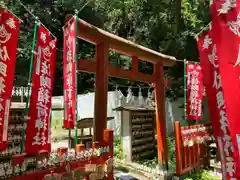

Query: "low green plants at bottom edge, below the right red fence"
<box><xmin>184</xmin><ymin>170</ymin><xmax>220</xmax><ymax>180</ymax></box>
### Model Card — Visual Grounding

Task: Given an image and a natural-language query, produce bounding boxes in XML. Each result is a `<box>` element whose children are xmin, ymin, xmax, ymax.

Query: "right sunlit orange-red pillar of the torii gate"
<box><xmin>154</xmin><ymin>63</ymin><xmax>168</xmax><ymax>174</ymax></box>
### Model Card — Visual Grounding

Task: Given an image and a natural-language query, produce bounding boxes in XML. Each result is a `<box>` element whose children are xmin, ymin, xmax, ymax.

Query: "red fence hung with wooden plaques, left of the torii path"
<box><xmin>9</xmin><ymin>130</ymin><xmax>113</xmax><ymax>180</ymax></box>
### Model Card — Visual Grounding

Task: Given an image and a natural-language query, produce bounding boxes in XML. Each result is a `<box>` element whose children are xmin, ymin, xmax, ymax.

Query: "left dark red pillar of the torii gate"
<box><xmin>93</xmin><ymin>43</ymin><xmax>108</xmax><ymax>143</ymax></box>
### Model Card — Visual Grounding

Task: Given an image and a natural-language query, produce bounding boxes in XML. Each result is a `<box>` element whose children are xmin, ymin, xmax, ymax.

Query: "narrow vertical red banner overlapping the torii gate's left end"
<box><xmin>63</xmin><ymin>18</ymin><xmax>77</xmax><ymax>128</ymax></box>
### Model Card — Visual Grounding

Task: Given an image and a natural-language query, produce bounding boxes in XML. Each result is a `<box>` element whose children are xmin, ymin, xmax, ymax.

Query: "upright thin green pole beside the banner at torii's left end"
<box><xmin>74</xmin><ymin>11</ymin><xmax>78</xmax><ymax>146</ymax></box>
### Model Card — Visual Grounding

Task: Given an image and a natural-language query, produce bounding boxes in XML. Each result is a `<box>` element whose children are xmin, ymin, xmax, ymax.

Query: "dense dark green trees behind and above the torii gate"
<box><xmin>3</xmin><ymin>0</ymin><xmax>210</xmax><ymax>98</ymax></box>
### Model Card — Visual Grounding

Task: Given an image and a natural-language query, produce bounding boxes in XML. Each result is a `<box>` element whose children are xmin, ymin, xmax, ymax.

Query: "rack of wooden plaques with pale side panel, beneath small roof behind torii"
<box><xmin>121</xmin><ymin>110</ymin><xmax>156</xmax><ymax>162</ymax></box>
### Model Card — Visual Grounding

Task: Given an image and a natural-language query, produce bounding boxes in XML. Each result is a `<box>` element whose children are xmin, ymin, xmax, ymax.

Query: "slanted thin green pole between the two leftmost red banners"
<box><xmin>21</xmin><ymin>21</ymin><xmax>38</xmax><ymax>153</ymax></box>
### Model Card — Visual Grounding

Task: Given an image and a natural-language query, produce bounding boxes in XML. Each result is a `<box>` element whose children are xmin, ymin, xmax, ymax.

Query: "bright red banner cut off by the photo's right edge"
<box><xmin>211</xmin><ymin>0</ymin><xmax>240</xmax><ymax>179</ymax></box>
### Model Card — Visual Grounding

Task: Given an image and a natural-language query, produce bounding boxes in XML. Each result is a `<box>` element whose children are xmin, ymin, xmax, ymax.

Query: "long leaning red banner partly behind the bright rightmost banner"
<box><xmin>198</xmin><ymin>25</ymin><xmax>237</xmax><ymax>180</ymax></box>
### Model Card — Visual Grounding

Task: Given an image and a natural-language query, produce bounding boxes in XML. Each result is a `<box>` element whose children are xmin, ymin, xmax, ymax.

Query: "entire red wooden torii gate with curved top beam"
<box><xmin>78</xmin><ymin>19</ymin><xmax>176</xmax><ymax>169</ymax></box>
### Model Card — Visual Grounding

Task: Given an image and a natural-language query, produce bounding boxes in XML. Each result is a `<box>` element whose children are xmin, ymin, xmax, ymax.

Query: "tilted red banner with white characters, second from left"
<box><xmin>25</xmin><ymin>25</ymin><xmax>56</xmax><ymax>154</ymax></box>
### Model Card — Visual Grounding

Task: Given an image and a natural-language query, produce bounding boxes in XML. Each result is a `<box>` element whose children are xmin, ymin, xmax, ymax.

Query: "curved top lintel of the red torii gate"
<box><xmin>75</xmin><ymin>19</ymin><xmax>176</xmax><ymax>67</ymax></box>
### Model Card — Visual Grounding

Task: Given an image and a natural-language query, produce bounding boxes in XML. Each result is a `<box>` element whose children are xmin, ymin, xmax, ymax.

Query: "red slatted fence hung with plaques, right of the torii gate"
<box><xmin>175</xmin><ymin>121</ymin><xmax>212</xmax><ymax>175</ymax></box>
